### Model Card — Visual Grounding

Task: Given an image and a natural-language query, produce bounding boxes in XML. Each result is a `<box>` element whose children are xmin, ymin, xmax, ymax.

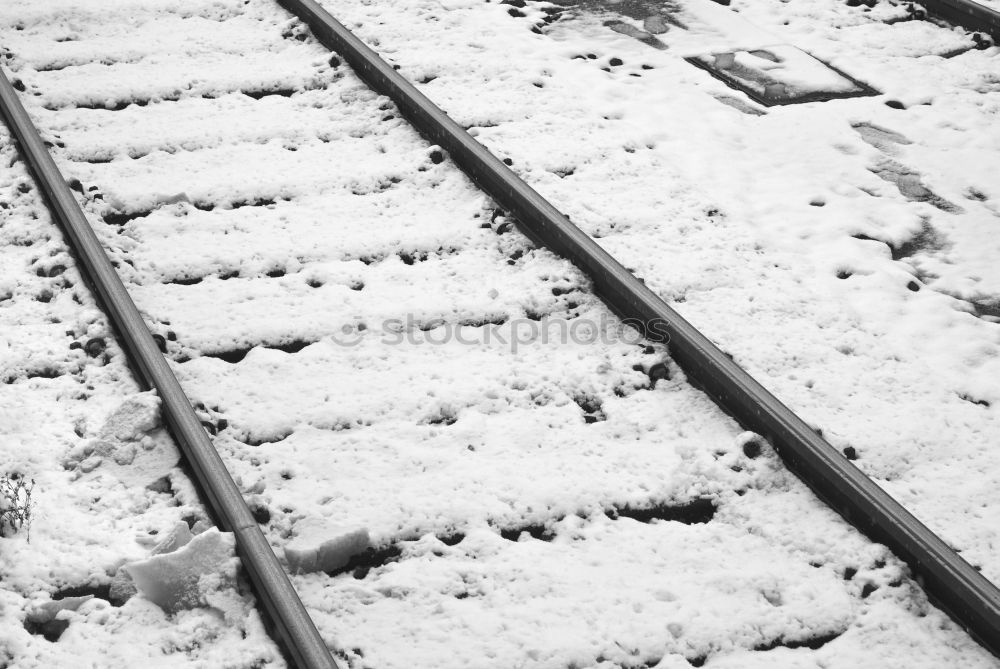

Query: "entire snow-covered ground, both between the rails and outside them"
<box><xmin>0</xmin><ymin>0</ymin><xmax>1000</xmax><ymax>669</ymax></box>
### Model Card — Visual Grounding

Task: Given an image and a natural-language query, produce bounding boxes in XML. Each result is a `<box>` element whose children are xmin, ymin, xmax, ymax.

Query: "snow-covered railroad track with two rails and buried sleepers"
<box><xmin>0</xmin><ymin>3</ymin><xmax>996</xmax><ymax>666</ymax></box>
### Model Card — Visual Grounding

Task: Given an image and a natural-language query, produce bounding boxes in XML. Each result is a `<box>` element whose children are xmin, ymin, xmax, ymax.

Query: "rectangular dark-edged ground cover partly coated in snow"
<box><xmin>686</xmin><ymin>45</ymin><xmax>878</xmax><ymax>107</ymax></box>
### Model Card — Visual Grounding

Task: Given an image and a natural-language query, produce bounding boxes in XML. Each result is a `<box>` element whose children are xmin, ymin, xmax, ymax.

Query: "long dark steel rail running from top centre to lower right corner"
<box><xmin>278</xmin><ymin>0</ymin><xmax>1000</xmax><ymax>655</ymax></box>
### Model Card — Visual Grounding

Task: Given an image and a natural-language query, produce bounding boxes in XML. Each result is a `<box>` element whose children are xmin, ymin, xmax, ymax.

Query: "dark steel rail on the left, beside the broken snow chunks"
<box><xmin>0</xmin><ymin>68</ymin><xmax>337</xmax><ymax>669</ymax></box>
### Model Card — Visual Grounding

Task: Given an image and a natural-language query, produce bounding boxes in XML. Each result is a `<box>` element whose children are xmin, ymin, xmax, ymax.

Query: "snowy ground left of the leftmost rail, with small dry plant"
<box><xmin>0</xmin><ymin>128</ymin><xmax>284</xmax><ymax>667</ymax></box>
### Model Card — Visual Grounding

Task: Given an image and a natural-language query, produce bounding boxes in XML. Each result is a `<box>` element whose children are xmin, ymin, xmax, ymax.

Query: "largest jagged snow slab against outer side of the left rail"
<box><xmin>125</xmin><ymin>527</ymin><xmax>239</xmax><ymax>613</ymax></box>
